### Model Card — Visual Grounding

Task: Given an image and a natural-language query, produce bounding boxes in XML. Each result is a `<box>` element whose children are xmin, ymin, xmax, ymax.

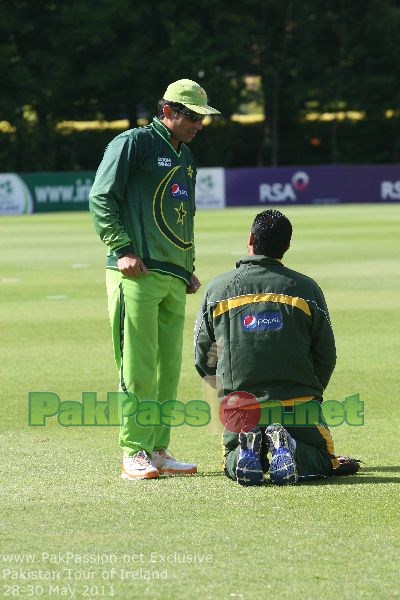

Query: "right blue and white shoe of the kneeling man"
<box><xmin>265</xmin><ymin>423</ymin><xmax>299</xmax><ymax>485</ymax></box>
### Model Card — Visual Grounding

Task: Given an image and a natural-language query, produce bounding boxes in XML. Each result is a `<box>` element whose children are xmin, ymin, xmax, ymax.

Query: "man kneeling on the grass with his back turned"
<box><xmin>195</xmin><ymin>210</ymin><xmax>359</xmax><ymax>485</ymax></box>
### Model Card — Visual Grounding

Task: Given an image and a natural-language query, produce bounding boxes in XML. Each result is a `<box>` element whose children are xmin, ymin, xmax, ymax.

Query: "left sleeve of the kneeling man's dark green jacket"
<box><xmin>194</xmin><ymin>292</ymin><xmax>217</xmax><ymax>378</ymax></box>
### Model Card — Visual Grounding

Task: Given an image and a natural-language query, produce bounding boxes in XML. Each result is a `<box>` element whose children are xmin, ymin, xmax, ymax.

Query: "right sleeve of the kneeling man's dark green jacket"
<box><xmin>311</xmin><ymin>286</ymin><xmax>336</xmax><ymax>389</ymax></box>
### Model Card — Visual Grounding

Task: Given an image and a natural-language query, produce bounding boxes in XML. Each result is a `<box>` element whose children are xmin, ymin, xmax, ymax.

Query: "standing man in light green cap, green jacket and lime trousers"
<box><xmin>89</xmin><ymin>79</ymin><xmax>220</xmax><ymax>480</ymax></box>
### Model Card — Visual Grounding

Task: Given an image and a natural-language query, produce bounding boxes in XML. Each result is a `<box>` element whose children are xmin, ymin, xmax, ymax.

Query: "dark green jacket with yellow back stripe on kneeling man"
<box><xmin>195</xmin><ymin>256</ymin><xmax>336</xmax><ymax>401</ymax></box>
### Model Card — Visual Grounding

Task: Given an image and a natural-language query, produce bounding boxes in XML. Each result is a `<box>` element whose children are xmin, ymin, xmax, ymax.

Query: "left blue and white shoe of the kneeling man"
<box><xmin>236</xmin><ymin>427</ymin><xmax>264</xmax><ymax>485</ymax></box>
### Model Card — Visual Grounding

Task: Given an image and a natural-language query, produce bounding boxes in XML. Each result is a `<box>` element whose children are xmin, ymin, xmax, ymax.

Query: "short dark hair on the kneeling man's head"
<box><xmin>251</xmin><ymin>209</ymin><xmax>292</xmax><ymax>258</ymax></box>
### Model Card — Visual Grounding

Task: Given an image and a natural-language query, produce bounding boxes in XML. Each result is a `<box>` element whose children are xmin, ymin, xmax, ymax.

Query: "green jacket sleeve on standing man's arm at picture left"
<box><xmin>89</xmin><ymin>136</ymin><xmax>135</xmax><ymax>258</ymax></box>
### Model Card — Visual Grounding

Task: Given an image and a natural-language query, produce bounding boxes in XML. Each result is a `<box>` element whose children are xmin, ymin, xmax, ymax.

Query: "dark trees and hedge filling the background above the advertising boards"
<box><xmin>0</xmin><ymin>0</ymin><xmax>400</xmax><ymax>172</ymax></box>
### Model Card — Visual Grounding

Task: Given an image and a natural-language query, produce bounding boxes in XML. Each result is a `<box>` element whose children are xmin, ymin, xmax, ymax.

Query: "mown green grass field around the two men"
<box><xmin>0</xmin><ymin>205</ymin><xmax>400</xmax><ymax>600</ymax></box>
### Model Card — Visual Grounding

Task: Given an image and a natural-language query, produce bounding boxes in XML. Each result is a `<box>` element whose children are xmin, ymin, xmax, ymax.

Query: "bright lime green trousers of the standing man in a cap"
<box><xmin>106</xmin><ymin>269</ymin><xmax>186</xmax><ymax>456</ymax></box>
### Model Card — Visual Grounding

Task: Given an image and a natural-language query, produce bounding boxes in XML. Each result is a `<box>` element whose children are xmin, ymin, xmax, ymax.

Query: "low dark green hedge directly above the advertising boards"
<box><xmin>0</xmin><ymin>119</ymin><xmax>400</xmax><ymax>172</ymax></box>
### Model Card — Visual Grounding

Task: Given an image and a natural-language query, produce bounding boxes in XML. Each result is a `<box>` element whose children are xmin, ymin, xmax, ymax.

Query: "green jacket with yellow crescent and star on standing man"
<box><xmin>89</xmin><ymin>118</ymin><xmax>196</xmax><ymax>284</ymax></box>
